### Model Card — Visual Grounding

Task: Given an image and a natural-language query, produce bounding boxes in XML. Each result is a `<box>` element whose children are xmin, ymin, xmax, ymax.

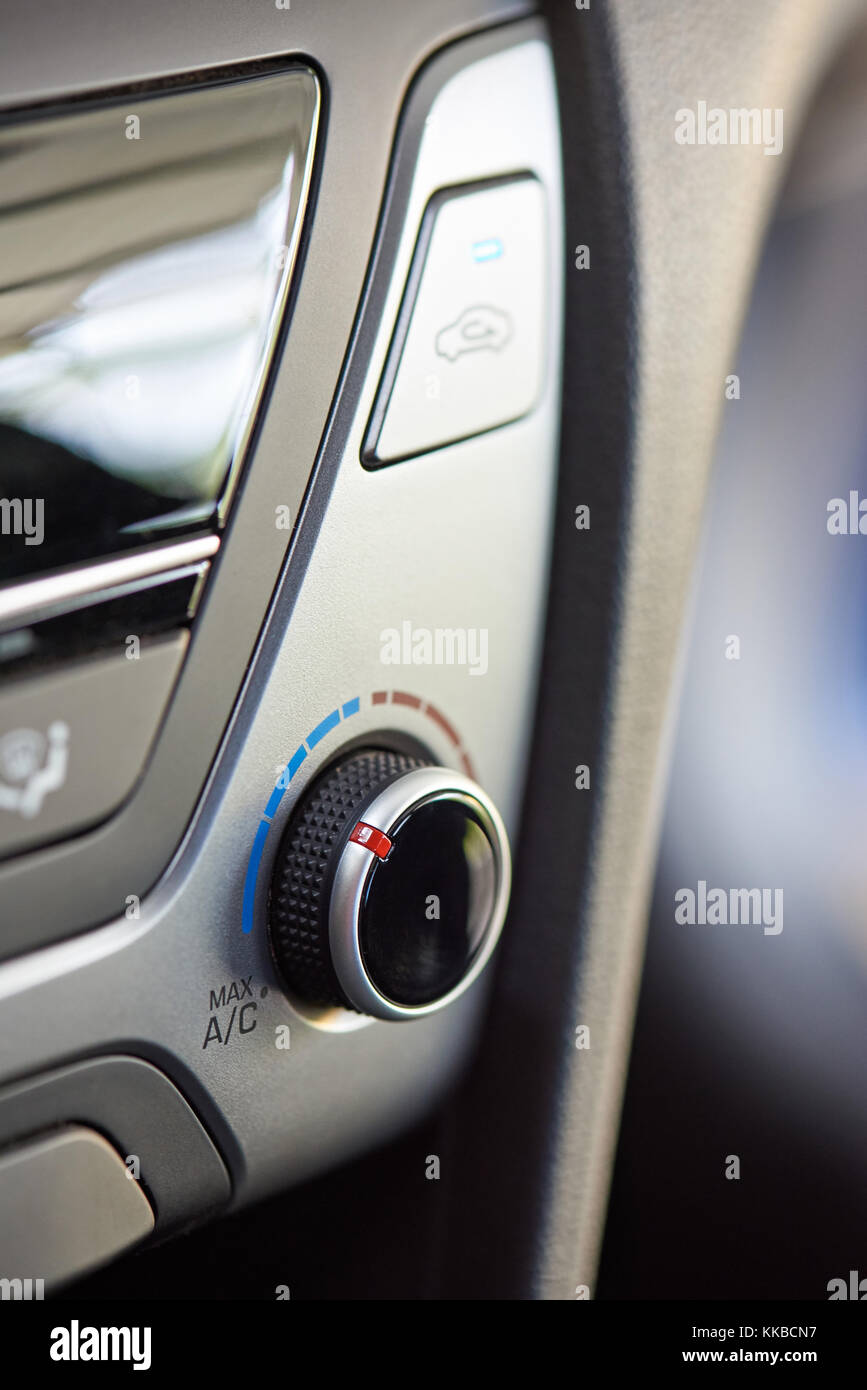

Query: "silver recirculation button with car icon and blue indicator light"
<box><xmin>364</xmin><ymin>177</ymin><xmax>547</xmax><ymax>467</ymax></box>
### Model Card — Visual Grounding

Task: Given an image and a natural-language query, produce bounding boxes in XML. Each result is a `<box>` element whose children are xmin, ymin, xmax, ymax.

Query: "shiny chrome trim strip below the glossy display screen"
<box><xmin>0</xmin><ymin>535</ymin><xmax>220</xmax><ymax>626</ymax></box>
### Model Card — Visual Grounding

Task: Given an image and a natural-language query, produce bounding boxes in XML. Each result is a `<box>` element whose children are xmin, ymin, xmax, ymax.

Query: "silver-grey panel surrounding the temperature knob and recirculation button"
<box><xmin>0</xmin><ymin>22</ymin><xmax>563</xmax><ymax>1202</ymax></box>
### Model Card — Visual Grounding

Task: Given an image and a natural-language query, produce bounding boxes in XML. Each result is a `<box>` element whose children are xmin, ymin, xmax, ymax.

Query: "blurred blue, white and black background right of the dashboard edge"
<box><xmin>597</xmin><ymin>21</ymin><xmax>867</xmax><ymax>1300</ymax></box>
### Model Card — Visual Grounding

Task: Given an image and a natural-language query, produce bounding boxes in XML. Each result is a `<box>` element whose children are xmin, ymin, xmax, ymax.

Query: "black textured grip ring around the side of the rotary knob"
<box><xmin>268</xmin><ymin>748</ymin><xmax>431</xmax><ymax>1008</ymax></box>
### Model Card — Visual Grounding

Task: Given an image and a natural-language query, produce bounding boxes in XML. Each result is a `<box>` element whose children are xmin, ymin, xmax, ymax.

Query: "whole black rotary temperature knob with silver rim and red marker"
<box><xmin>268</xmin><ymin>748</ymin><xmax>511</xmax><ymax>1019</ymax></box>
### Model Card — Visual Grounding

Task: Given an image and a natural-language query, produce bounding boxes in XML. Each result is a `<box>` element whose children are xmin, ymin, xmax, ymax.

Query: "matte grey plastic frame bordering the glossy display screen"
<box><xmin>0</xmin><ymin>0</ymin><xmax>529</xmax><ymax>955</ymax></box>
